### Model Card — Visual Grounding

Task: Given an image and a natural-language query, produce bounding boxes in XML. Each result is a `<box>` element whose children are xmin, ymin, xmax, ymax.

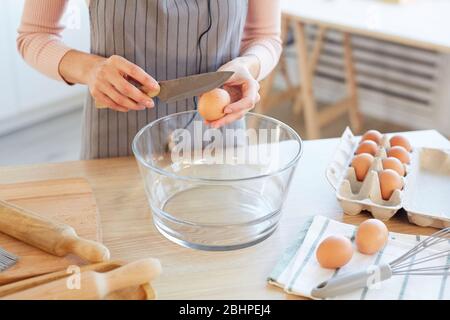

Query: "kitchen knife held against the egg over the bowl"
<box><xmin>96</xmin><ymin>71</ymin><xmax>234</xmax><ymax>109</ymax></box>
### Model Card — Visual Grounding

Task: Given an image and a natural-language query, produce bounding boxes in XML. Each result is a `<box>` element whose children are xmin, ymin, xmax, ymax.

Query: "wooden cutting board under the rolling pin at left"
<box><xmin>0</xmin><ymin>178</ymin><xmax>102</xmax><ymax>285</ymax></box>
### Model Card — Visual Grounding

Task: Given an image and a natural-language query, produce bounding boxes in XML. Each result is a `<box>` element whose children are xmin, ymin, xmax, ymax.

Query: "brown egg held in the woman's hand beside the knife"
<box><xmin>198</xmin><ymin>88</ymin><xmax>231</xmax><ymax>121</ymax></box>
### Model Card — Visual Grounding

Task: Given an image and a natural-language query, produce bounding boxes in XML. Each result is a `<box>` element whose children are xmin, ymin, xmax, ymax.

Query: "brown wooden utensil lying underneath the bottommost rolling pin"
<box><xmin>0</xmin><ymin>261</ymin><xmax>156</xmax><ymax>300</ymax></box>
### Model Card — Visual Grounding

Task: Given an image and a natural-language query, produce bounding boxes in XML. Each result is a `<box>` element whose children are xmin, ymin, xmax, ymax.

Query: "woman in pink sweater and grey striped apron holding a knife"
<box><xmin>17</xmin><ymin>0</ymin><xmax>281</xmax><ymax>159</ymax></box>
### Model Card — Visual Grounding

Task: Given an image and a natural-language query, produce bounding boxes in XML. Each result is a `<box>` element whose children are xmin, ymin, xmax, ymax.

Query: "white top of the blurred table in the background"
<box><xmin>281</xmin><ymin>0</ymin><xmax>450</xmax><ymax>52</ymax></box>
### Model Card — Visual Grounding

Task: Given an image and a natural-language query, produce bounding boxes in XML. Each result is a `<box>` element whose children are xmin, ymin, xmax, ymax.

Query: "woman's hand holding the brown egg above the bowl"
<box><xmin>207</xmin><ymin>58</ymin><xmax>260</xmax><ymax>128</ymax></box>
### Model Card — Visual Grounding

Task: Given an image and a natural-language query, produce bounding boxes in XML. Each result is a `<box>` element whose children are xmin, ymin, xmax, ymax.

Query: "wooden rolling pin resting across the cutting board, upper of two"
<box><xmin>0</xmin><ymin>200</ymin><xmax>109</xmax><ymax>262</ymax></box>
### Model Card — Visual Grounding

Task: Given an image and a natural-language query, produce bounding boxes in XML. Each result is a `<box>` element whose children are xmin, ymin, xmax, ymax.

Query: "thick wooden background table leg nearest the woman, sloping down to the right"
<box><xmin>293</xmin><ymin>22</ymin><xmax>320</xmax><ymax>139</ymax></box>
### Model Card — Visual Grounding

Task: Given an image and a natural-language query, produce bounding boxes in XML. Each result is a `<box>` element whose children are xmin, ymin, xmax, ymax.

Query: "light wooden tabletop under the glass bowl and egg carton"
<box><xmin>0</xmin><ymin>130</ymin><xmax>450</xmax><ymax>299</ymax></box>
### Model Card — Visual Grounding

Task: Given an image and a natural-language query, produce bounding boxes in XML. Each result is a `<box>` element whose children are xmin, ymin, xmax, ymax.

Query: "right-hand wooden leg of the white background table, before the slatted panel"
<box><xmin>343</xmin><ymin>32</ymin><xmax>362</xmax><ymax>133</ymax></box>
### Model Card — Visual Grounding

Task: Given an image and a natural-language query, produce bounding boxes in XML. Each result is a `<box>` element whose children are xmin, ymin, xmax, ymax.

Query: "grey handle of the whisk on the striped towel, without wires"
<box><xmin>311</xmin><ymin>264</ymin><xmax>392</xmax><ymax>299</ymax></box>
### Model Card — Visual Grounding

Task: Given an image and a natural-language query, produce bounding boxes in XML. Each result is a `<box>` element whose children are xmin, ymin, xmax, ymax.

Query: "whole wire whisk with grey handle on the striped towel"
<box><xmin>311</xmin><ymin>228</ymin><xmax>450</xmax><ymax>298</ymax></box>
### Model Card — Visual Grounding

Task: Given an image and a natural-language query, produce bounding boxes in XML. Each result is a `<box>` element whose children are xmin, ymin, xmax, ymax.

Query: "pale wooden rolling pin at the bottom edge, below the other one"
<box><xmin>2</xmin><ymin>258</ymin><xmax>161</xmax><ymax>300</ymax></box>
